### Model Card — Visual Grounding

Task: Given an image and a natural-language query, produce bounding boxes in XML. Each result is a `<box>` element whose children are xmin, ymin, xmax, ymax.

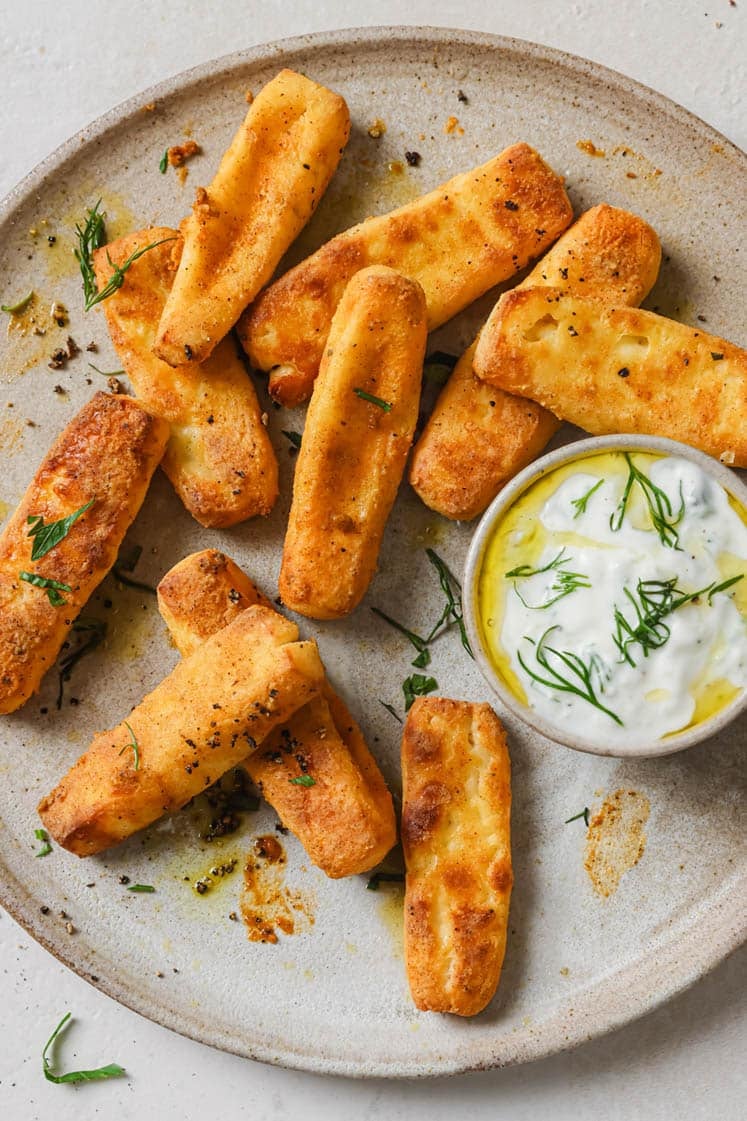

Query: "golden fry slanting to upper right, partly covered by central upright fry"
<box><xmin>238</xmin><ymin>143</ymin><xmax>572</xmax><ymax>405</ymax></box>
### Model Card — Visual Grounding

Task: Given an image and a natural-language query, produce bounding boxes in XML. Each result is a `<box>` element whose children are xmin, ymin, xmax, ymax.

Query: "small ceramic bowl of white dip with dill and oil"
<box><xmin>464</xmin><ymin>436</ymin><xmax>747</xmax><ymax>757</ymax></box>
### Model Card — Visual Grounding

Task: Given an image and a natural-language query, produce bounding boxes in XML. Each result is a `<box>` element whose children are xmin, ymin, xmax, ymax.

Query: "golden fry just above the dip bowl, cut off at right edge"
<box><xmin>474</xmin><ymin>288</ymin><xmax>747</xmax><ymax>467</ymax></box>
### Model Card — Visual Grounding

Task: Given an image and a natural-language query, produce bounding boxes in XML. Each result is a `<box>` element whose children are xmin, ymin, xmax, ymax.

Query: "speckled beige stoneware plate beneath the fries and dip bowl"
<box><xmin>0</xmin><ymin>28</ymin><xmax>747</xmax><ymax>1076</ymax></box>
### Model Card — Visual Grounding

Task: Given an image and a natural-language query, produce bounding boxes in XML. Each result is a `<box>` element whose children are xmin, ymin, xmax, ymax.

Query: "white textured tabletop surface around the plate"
<box><xmin>0</xmin><ymin>0</ymin><xmax>747</xmax><ymax>1121</ymax></box>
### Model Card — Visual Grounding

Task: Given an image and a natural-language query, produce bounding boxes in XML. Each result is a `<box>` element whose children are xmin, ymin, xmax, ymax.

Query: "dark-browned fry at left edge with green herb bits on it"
<box><xmin>0</xmin><ymin>393</ymin><xmax>168</xmax><ymax>713</ymax></box>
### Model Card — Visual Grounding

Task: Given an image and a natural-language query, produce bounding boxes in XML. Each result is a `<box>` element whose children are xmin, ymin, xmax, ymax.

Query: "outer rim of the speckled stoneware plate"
<box><xmin>0</xmin><ymin>25</ymin><xmax>747</xmax><ymax>1078</ymax></box>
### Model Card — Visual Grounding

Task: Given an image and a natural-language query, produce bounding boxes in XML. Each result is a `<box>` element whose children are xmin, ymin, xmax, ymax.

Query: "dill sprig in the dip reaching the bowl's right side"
<box><xmin>612</xmin><ymin>574</ymin><xmax>743</xmax><ymax>668</ymax></box>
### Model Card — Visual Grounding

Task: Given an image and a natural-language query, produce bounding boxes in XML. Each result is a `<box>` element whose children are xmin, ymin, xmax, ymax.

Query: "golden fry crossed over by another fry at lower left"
<box><xmin>158</xmin><ymin>549</ymin><xmax>397</xmax><ymax>879</ymax></box>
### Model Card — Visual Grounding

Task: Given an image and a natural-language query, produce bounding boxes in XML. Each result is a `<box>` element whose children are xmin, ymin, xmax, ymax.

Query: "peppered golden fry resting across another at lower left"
<box><xmin>39</xmin><ymin>606</ymin><xmax>324</xmax><ymax>856</ymax></box>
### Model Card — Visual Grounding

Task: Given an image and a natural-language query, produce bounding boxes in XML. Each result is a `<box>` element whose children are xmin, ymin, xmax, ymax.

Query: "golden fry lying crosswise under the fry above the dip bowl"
<box><xmin>408</xmin><ymin>203</ymin><xmax>662</xmax><ymax>521</ymax></box>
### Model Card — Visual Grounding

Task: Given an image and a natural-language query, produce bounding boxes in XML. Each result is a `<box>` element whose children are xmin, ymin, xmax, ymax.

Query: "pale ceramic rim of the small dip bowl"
<box><xmin>463</xmin><ymin>433</ymin><xmax>747</xmax><ymax>759</ymax></box>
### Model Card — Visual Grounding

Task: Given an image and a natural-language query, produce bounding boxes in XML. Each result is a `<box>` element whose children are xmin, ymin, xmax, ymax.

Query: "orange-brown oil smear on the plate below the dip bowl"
<box><xmin>583</xmin><ymin>790</ymin><xmax>651</xmax><ymax>899</ymax></box>
